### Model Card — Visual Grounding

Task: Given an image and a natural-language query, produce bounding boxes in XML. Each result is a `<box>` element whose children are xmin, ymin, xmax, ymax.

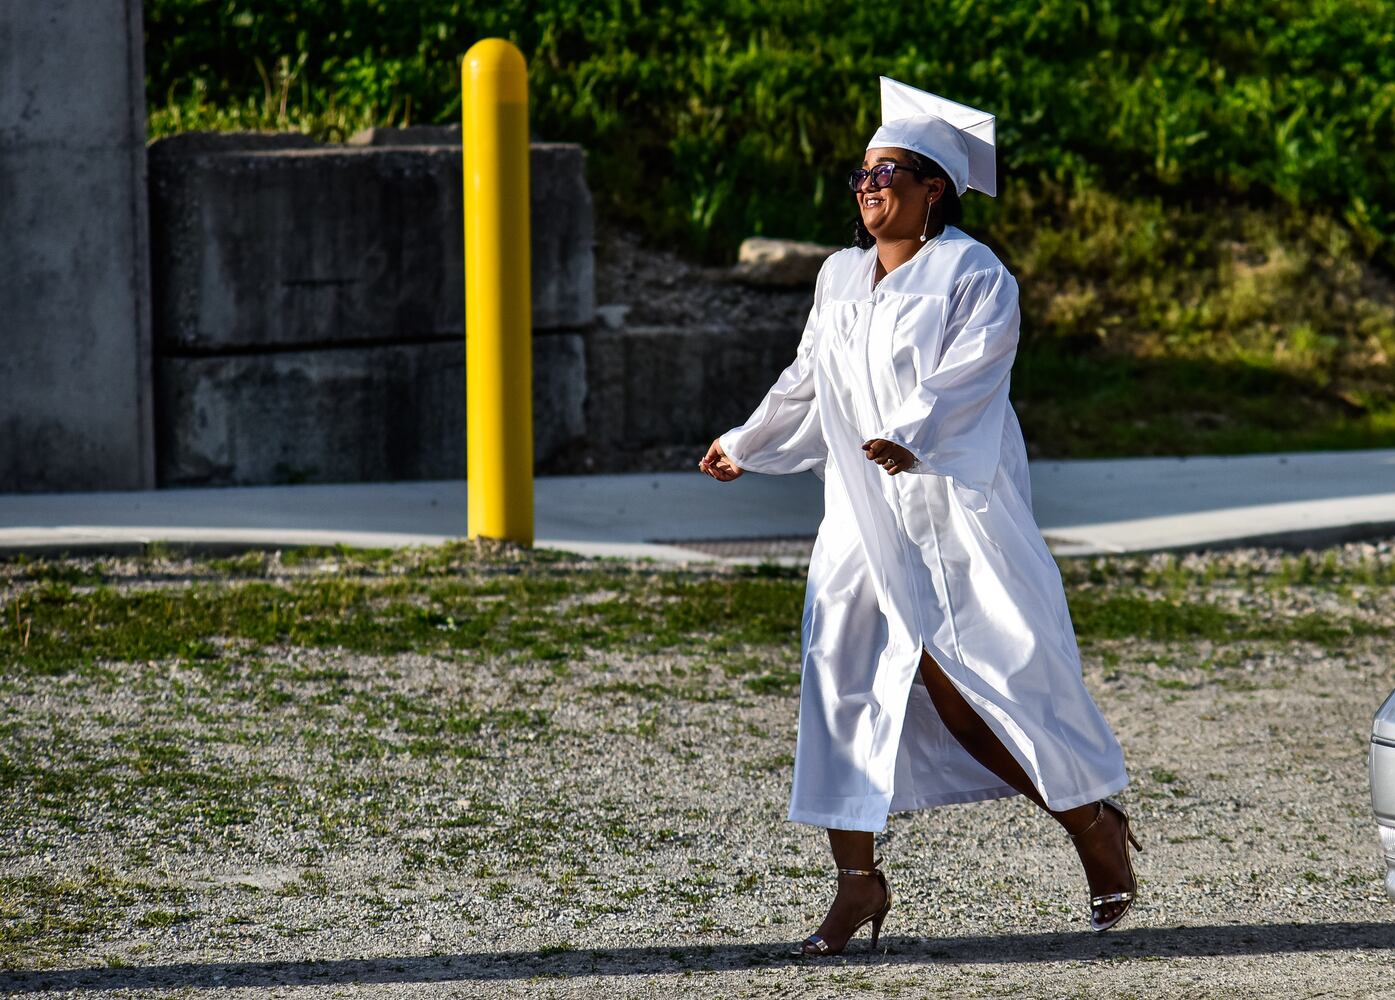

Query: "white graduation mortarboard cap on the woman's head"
<box><xmin>868</xmin><ymin>77</ymin><xmax>997</xmax><ymax>195</ymax></box>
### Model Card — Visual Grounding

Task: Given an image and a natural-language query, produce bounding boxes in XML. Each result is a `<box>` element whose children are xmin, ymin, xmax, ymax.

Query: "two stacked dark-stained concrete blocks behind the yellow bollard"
<box><xmin>151</xmin><ymin>130</ymin><xmax>596</xmax><ymax>485</ymax></box>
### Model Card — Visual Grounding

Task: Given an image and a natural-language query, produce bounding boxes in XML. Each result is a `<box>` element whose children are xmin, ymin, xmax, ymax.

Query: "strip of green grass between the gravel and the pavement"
<box><xmin>0</xmin><ymin>544</ymin><xmax>1395</xmax><ymax>677</ymax></box>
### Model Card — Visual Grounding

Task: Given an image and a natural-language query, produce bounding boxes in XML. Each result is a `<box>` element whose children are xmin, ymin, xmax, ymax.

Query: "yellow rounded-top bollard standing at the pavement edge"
<box><xmin>460</xmin><ymin>38</ymin><xmax>533</xmax><ymax>545</ymax></box>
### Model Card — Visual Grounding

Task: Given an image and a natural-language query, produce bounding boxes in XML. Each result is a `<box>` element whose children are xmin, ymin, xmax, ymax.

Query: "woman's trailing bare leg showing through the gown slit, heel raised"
<box><xmin>921</xmin><ymin>650</ymin><xmax>1130</xmax><ymax>918</ymax></box>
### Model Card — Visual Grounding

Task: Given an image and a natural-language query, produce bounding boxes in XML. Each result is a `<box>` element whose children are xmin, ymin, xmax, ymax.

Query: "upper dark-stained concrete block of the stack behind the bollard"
<box><xmin>151</xmin><ymin>130</ymin><xmax>596</xmax><ymax>347</ymax></box>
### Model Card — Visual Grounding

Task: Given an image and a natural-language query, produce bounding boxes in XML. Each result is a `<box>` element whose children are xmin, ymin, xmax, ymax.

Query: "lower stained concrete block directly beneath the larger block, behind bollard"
<box><xmin>156</xmin><ymin>333</ymin><xmax>585</xmax><ymax>487</ymax></box>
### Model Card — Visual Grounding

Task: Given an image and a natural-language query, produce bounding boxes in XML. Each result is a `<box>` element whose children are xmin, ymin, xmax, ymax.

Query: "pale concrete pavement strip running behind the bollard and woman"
<box><xmin>0</xmin><ymin>449</ymin><xmax>1395</xmax><ymax>561</ymax></box>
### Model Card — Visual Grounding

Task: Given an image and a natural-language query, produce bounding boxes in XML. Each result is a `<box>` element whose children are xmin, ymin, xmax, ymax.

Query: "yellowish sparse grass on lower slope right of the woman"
<box><xmin>992</xmin><ymin>184</ymin><xmax>1395</xmax><ymax>457</ymax></box>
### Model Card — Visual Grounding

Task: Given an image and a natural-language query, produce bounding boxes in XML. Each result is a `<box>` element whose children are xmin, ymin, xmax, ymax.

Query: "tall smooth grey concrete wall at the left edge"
<box><xmin>0</xmin><ymin>0</ymin><xmax>155</xmax><ymax>491</ymax></box>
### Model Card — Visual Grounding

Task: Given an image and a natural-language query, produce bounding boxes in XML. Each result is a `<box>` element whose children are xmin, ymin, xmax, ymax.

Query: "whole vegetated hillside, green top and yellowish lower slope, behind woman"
<box><xmin>145</xmin><ymin>0</ymin><xmax>1395</xmax><ymax>456</ymax></box>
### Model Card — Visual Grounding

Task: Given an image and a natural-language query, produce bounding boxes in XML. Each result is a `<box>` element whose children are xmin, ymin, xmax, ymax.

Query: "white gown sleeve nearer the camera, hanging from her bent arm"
<box><xmin>873</xmin><ymin>265</ymin><xmax>1020</xmax><ymax>512</ymax></box>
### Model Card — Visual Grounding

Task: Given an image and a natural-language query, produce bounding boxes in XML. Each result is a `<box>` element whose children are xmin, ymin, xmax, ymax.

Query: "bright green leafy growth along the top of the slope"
<box><xmin>145</xmin><ymin>0</ymin><xmax>1395</xmax><ymax>259</ymax></box>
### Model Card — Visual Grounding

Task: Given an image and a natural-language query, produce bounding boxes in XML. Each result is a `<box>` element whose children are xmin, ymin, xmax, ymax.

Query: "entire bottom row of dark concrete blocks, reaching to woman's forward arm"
<box><xmin>156</xmin><ymin>309</ymin><xmax>799</xmax><ymax>485</ymax></box>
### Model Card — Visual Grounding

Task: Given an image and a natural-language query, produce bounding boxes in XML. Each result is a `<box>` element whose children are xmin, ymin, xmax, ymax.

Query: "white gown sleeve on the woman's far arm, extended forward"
<box><xmin>718</xmin><ymin>259</ymin><xmax>829</xmax><ymax>478</ymax></box>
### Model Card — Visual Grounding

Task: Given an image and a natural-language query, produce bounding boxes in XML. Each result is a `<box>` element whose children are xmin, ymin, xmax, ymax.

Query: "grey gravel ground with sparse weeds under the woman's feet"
<box><xmin>0</xmin><ymin>544</ymin><xmax>1395</xmax><ymax>999</ymax></box>
